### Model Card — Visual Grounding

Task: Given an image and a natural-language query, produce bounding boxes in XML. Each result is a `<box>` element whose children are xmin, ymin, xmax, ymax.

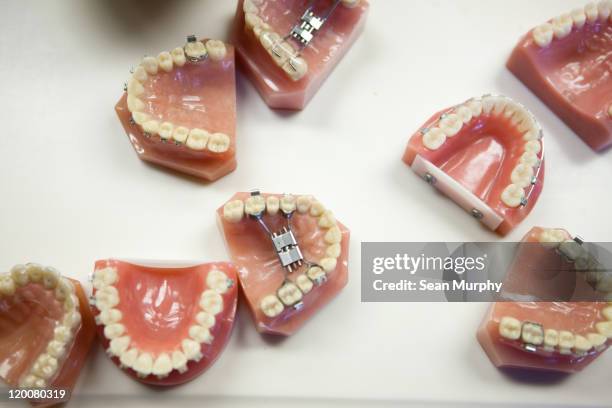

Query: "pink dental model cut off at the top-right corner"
<box><xmin>507</xmin><ymin>0</ymin><xmax>612</xmax><ymax>150</ymax></box>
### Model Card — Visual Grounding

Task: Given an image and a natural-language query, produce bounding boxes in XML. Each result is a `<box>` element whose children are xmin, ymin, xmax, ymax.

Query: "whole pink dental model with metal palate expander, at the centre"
<box><xmin>217</xmin><ymin>191</ymin><xmax>349</xmax><ymax>336</ymax></box>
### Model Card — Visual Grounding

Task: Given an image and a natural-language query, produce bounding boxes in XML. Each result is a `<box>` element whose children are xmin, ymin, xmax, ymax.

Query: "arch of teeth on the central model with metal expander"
<box><xmin>223</xmin><ymin>192</ymin><xmax>342</xmax><ymax>319</ymax></box>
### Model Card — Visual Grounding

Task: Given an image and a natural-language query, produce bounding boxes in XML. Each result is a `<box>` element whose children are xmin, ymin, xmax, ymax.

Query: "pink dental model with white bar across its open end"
<box><xmin>403</xmin><ymin>95</ymin><xmax>544</xmax><ymax>235</ymax></box>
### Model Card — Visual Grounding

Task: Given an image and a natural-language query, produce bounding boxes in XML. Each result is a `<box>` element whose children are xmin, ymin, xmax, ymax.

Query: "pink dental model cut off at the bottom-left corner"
<box><xmin>0</xmin><ymin>263</ymin><xmax>95</xmax><ymax>404</ymax></box>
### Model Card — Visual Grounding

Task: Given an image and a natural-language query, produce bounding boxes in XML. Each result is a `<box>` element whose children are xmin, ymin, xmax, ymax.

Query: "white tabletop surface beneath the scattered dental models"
<box><xmin>0</xmin><ymin>0</ymin><xmax>612</xmax><ymax>407</ymax></box>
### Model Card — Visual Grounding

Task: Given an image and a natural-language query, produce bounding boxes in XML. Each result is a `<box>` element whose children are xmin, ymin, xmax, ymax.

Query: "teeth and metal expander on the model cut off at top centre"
<box><xmin>243</xmin><ymin>0</ymin><xmax>361</xmax><ymax>81</ymax></box>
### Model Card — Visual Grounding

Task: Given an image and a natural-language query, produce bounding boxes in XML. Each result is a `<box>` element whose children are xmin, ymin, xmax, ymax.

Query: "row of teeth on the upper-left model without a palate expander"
<box><xmin>125</xmin><ymin>36</ymin><xmax>231</xmax><ymax>153</ymax></box>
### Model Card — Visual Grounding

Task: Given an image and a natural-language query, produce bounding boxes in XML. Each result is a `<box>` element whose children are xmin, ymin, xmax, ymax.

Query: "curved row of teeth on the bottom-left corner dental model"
<box><xmin>0</xmin><ymin>263</ymin><xmax>82</xmax><ymax>388</ymax></box>
